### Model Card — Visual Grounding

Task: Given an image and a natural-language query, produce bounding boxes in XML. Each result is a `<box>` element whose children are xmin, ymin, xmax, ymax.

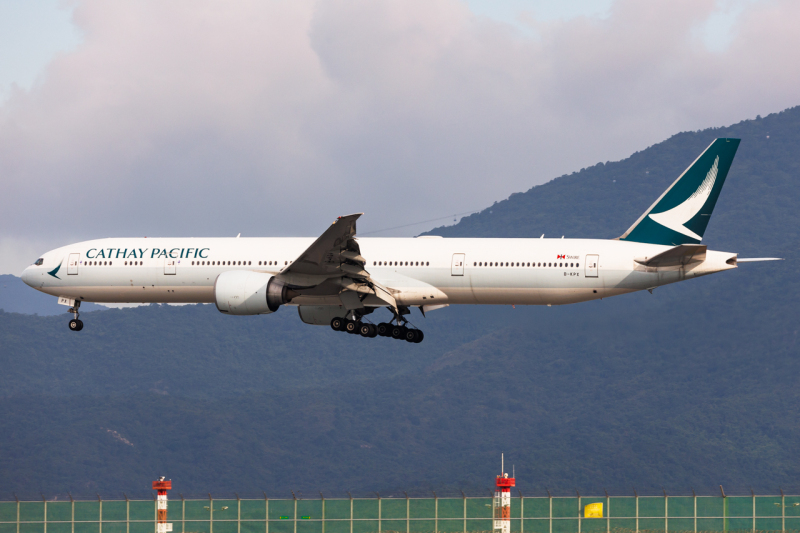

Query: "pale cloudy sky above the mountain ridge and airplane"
<box><xmin>0</xmin><ymin>0</ymin><xmax>800</xmax><ymax>274</ymax></box>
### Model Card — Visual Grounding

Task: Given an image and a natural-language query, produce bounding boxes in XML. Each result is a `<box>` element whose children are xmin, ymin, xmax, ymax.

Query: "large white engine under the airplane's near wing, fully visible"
<box><xmin>214</xmin><ymin>270</ymin><xmax>295</xmax><ymax>315</ymax></box>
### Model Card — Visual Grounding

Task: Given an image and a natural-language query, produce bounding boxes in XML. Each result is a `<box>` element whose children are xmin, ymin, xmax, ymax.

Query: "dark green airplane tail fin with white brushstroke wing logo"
<box><xmin>619</xmin><ymin>139</ymin><xmax>740</xmax><ymax>246</ymax></box>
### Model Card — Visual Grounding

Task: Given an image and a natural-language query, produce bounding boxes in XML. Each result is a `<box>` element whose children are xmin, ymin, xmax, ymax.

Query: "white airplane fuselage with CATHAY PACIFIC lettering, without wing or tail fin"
<box><xmin>23</xmin><ymin>237</ymin><xmax>736</xmax><ymax>306</ymax></box>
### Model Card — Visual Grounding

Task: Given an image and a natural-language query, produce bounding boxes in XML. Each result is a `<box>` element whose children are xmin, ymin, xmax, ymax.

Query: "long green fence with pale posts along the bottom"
<box><xmin>0</xmin><ymin>495</ymin><xmax>800</xmax><ymax>533</ymax></box>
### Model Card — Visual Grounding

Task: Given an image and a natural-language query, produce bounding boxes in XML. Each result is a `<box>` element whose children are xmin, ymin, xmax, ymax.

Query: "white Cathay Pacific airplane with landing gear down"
<box><xmin>22</xmin><ymin>138</ymin><xmax>779</xmax><ymax>343</ymax></box>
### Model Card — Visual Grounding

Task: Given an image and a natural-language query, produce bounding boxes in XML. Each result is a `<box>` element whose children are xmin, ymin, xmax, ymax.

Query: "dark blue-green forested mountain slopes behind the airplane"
<box><xmin>0</xmin><ymin>108</ymin><xmax>800</xmax><ymax>498</ymax></box>
